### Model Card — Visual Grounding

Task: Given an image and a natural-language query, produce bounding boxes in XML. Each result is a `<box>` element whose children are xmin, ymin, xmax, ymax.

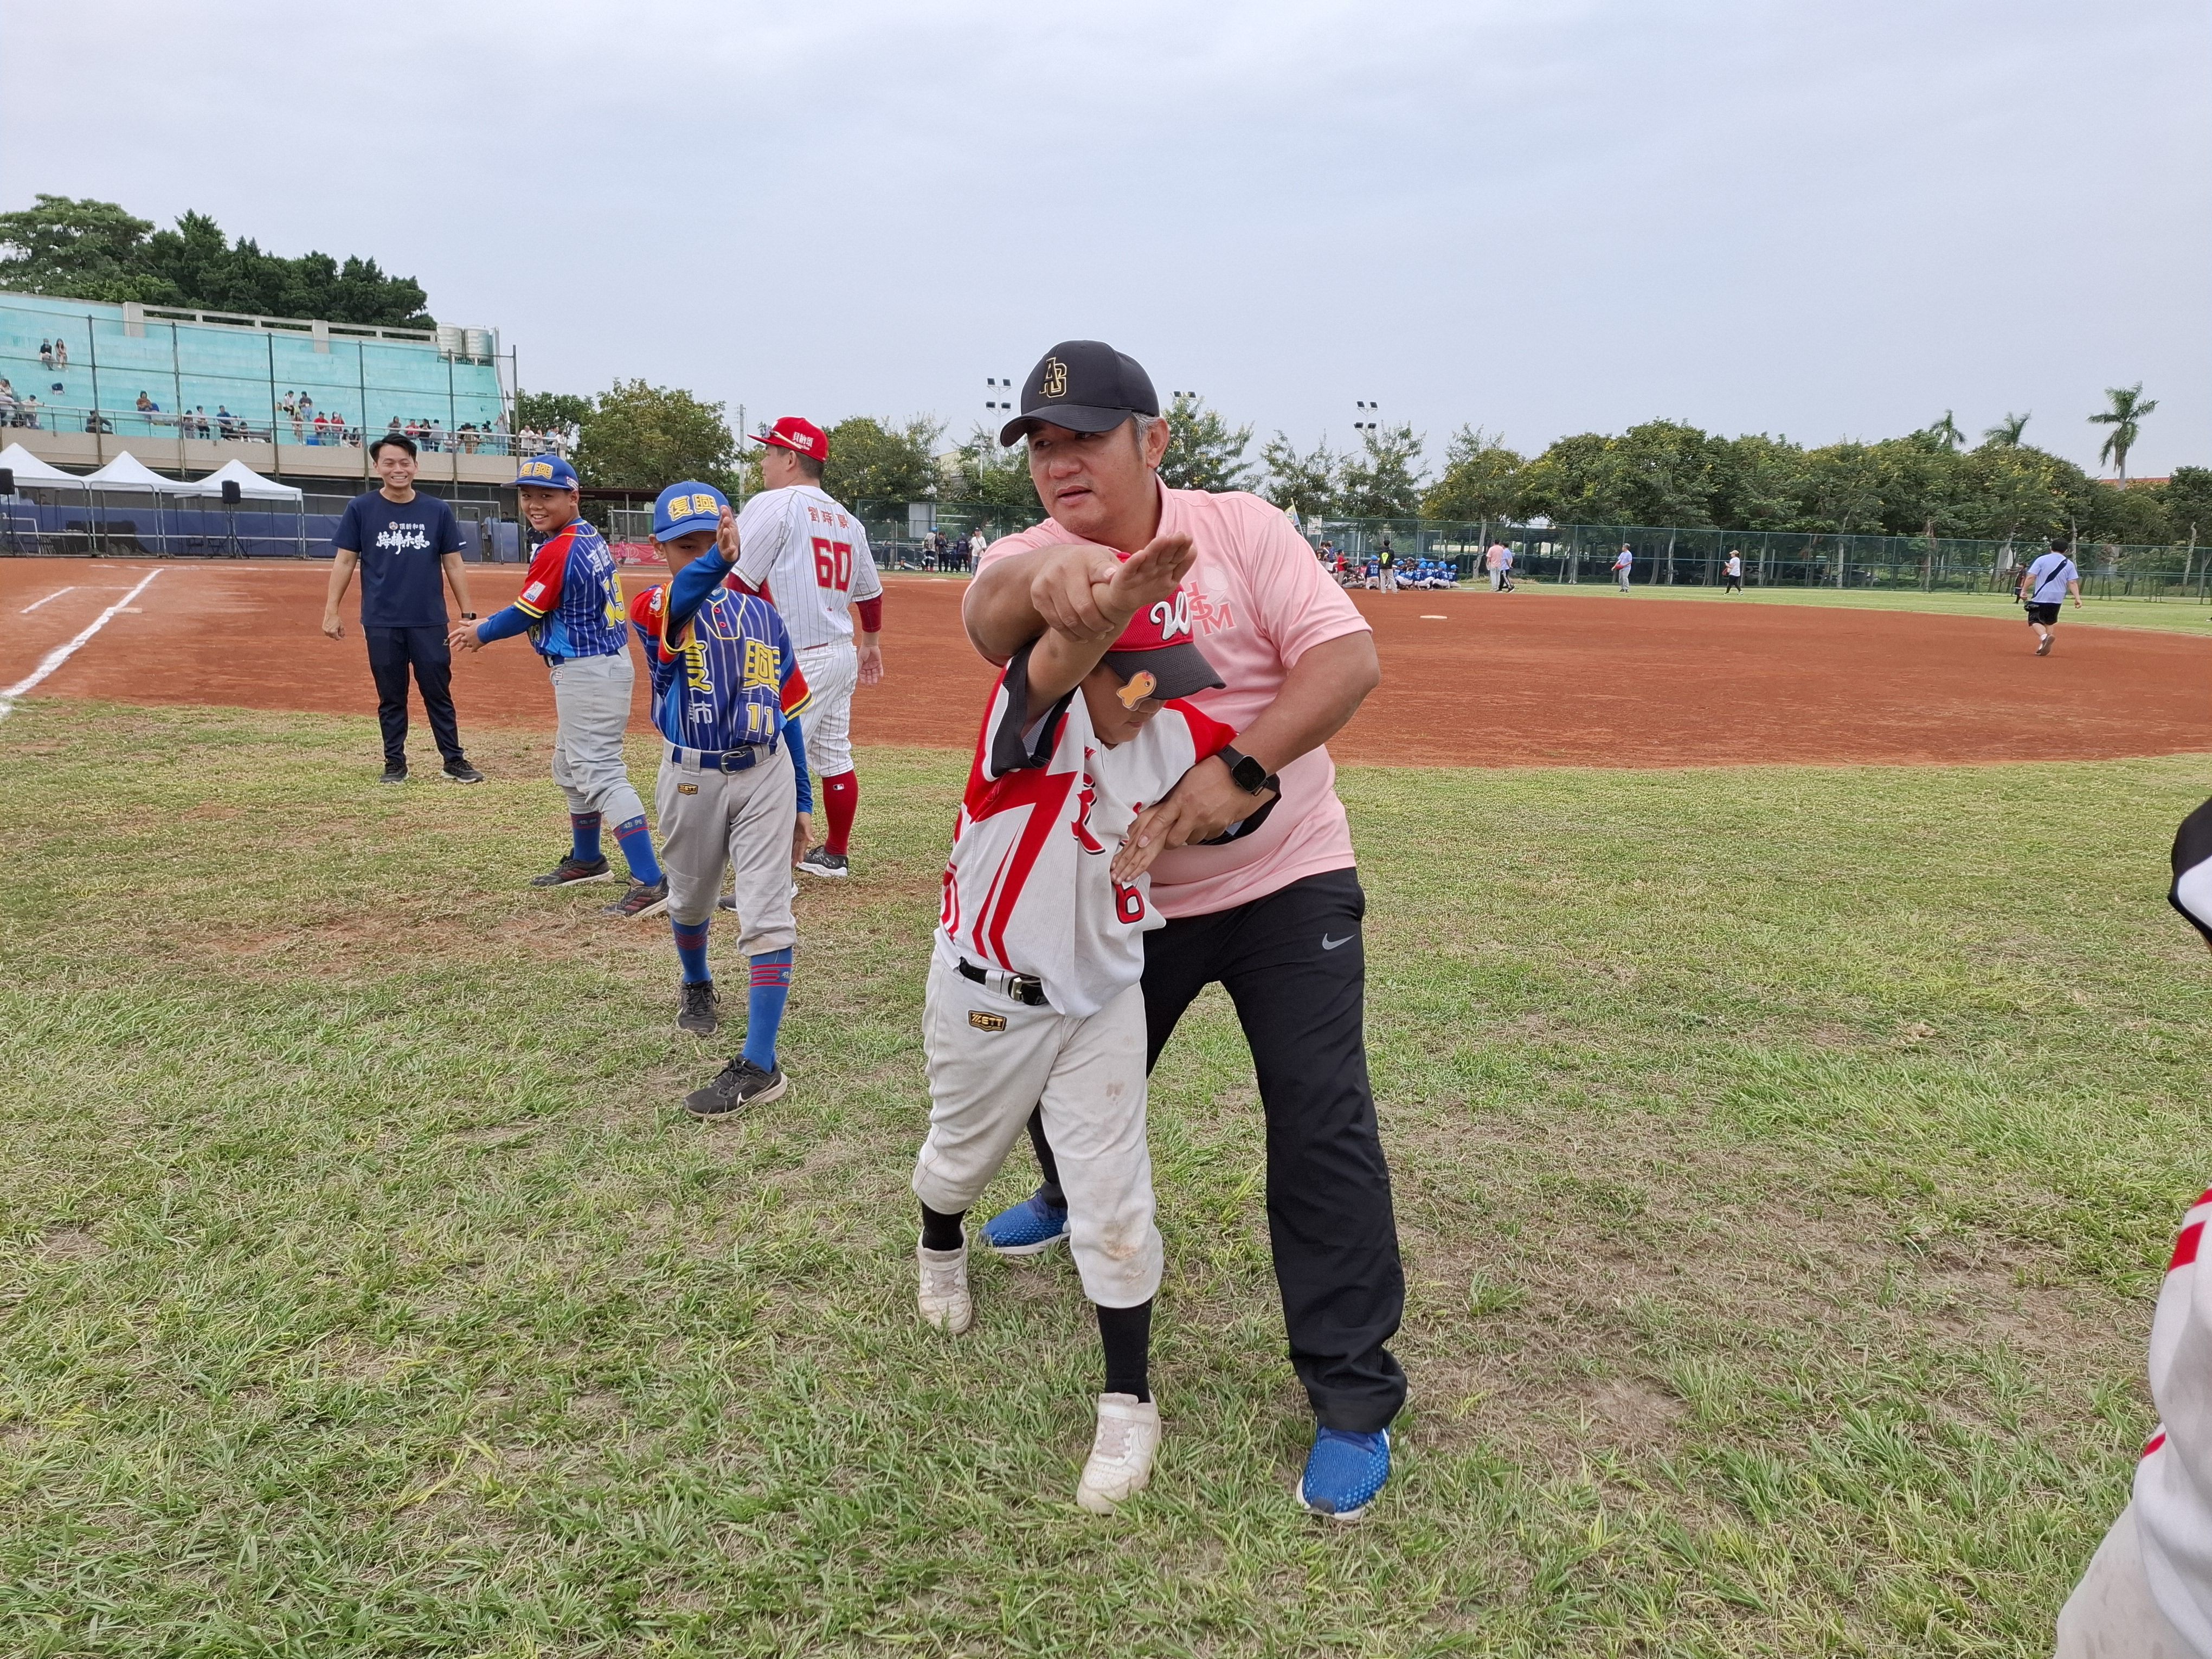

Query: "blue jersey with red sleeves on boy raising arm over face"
<box><xmin>631</xmin><ymin>557</ymin><xmax>812</xmax><ymax>750</ymax></box>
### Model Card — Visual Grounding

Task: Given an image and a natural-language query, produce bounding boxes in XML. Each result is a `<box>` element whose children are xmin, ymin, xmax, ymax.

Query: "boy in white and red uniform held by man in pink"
<box><xmin>914</xmin><ymin>535</ymin><xmax>1234</xmax><ymax>1513</ymax></box>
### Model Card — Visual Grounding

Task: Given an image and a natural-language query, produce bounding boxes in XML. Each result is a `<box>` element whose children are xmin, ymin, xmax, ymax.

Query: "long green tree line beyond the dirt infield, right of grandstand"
<box><xmin>518</xmin><ymin>381</ymin><xmax>2212</xmax><ymax>544</ymax></box>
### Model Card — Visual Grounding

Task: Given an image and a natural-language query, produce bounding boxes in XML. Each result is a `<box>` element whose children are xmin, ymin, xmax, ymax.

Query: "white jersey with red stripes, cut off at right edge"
<box><xmin>2134</xmin><ymin>1192</ymin><xmax>2212</xmax><ymax>1655</ymax></box>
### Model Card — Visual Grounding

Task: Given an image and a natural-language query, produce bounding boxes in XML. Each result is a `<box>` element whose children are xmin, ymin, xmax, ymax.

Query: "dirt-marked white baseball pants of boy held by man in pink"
<box><xmin>914</xmin><ymin>949</ymin><xmax>1163</xmax><ymax>1307</ymax></box>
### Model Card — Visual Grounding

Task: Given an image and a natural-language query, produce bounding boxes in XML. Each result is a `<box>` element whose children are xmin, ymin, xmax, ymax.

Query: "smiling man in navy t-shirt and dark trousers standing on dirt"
<box><xmin>323</xmin><ymin>432</ymin><xmax>485</xmax><ymax>783</ymax></box>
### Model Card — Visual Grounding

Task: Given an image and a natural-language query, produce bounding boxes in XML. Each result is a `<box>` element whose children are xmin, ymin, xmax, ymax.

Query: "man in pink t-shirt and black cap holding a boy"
<box><xmin>962</xmin><ymin>340</ymin><xmax>1405</xmax><ymax>1520</ymax></box>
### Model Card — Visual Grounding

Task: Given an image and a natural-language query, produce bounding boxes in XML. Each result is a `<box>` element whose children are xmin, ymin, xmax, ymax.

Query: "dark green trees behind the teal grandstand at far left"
<box><xmin>0</xmin><ymin>195</ymin><xmax>434</xmax><ymax>327</ymax></box>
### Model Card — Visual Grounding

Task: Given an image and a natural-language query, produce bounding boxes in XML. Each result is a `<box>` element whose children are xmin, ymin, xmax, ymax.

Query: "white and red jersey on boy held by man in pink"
<box><xmin>938</xmin><ymin>651</ymin><xmax>1234</xmax><ymax>1015</ymax></box>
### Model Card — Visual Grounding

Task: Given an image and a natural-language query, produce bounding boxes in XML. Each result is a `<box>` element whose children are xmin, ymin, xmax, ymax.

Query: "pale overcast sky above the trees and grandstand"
<box><xmin>0</xmin><ymin>0</ymin><xmax>2212</xmax><ymax>475</ymax></box>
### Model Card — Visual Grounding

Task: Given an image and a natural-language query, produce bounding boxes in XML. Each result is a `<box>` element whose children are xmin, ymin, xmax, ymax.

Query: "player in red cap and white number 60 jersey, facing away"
<box><xmin>737</xmin><ymin>416</ymin><xmax>883</xmax><ymax>878</ymax></box>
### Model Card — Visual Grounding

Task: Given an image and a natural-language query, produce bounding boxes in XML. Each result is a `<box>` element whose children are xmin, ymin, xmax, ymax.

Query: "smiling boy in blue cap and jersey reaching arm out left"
<box><xmin>451</xmin><ymin>455</ymin><xmax>668</xmax><ymax>918</ymax></box>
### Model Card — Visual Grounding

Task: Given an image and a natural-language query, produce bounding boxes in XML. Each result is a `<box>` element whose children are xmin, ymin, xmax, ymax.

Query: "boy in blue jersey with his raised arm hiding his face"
<box><xmin>631</xmin><ymin>480</ymin><xmax>814</xmax><ymax>1122</ymax></box>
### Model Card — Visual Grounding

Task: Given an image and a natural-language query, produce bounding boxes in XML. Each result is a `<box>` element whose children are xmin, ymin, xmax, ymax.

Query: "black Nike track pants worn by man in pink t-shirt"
<box><xmin>1028</xmin><ymin>869</ymin><xmax>1405</xmax><ymax>1433</ymax></box>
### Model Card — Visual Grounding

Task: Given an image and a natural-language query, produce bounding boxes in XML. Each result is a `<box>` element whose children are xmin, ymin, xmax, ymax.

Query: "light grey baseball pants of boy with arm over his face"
<box><xmin>653</xmin><ymin>743</ymin><xmax>799</xmax><ymax>956</ymax></box>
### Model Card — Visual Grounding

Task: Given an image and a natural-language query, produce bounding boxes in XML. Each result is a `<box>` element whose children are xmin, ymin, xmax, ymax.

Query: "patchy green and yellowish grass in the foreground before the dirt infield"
<box><xmin>0</xmin><ymin>703</ymin><xmax>2212</xmax><ymax>1659</ymax></box>
